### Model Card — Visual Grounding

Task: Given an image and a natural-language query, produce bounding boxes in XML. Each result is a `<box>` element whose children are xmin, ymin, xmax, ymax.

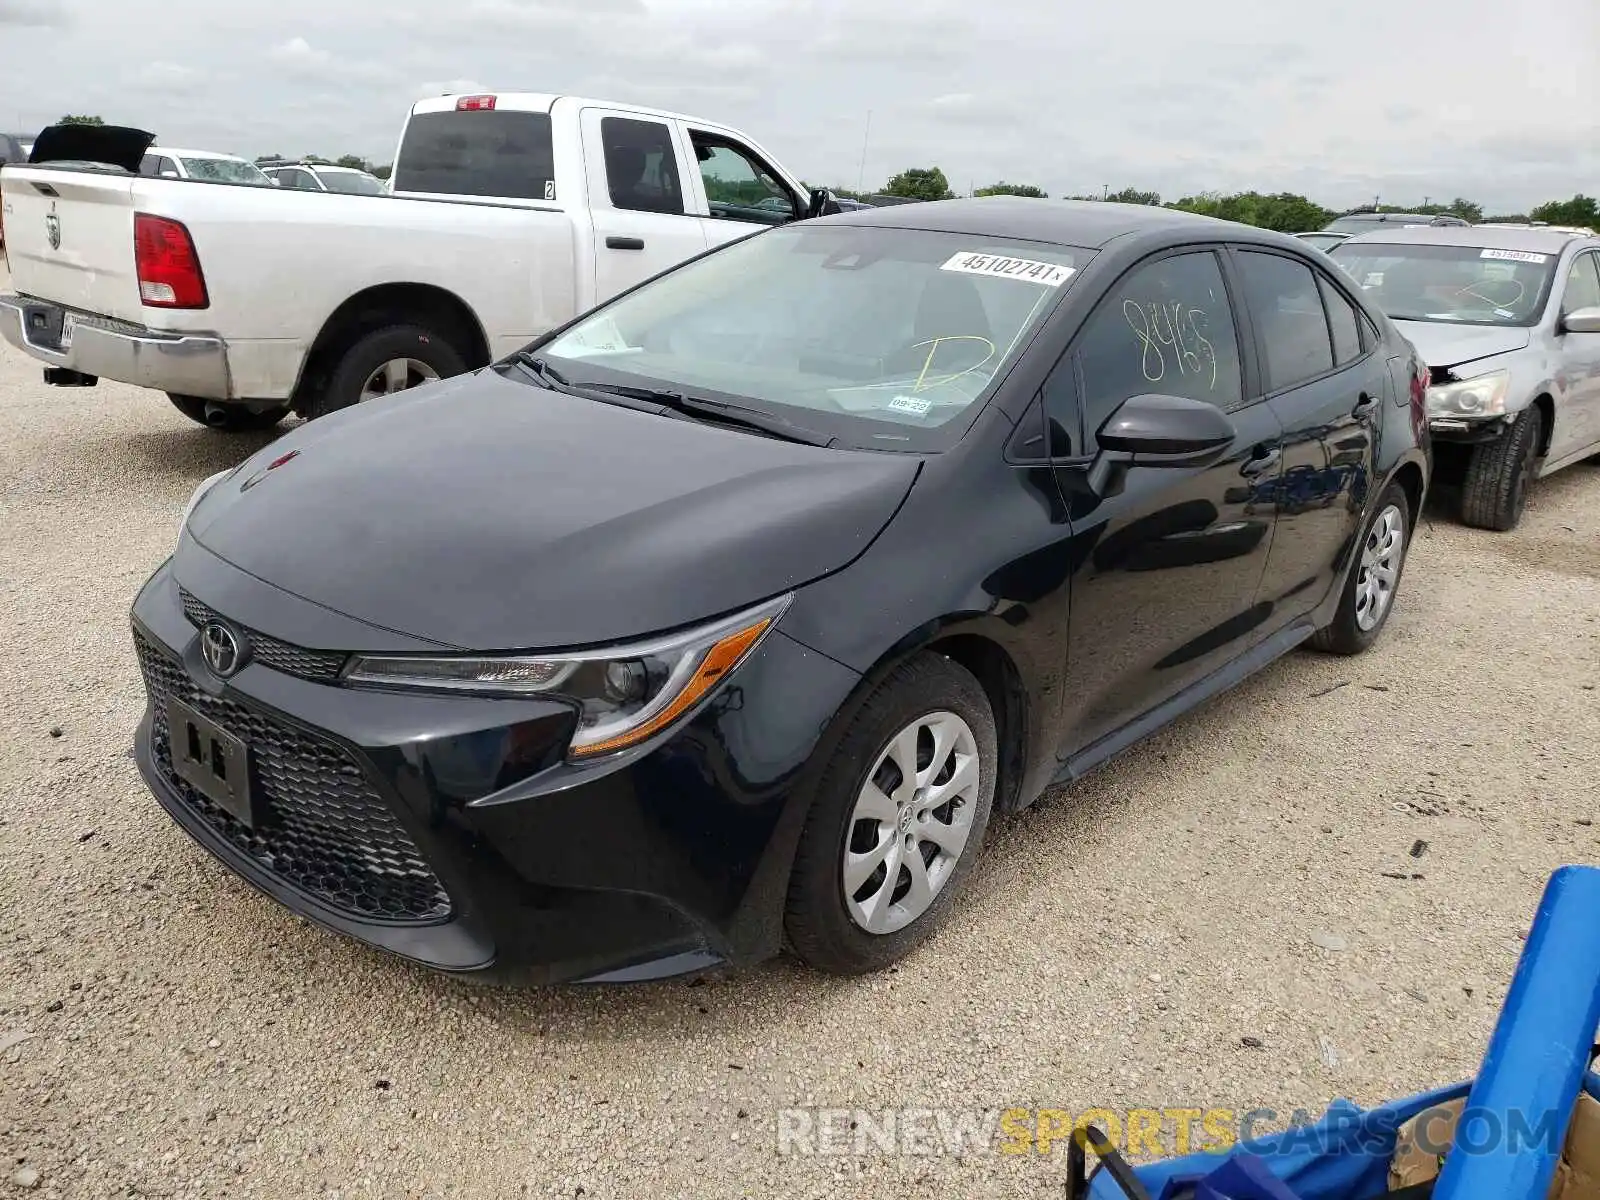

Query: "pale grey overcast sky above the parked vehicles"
<box><xmin>0</xmin><ymin>0</ymin><xmax>1600</xmax><ymax>211</ymax></box>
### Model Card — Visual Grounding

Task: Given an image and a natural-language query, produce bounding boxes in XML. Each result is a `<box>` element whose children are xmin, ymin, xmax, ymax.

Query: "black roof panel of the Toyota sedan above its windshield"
<box><xmin>822</xmin><ymin>195</ymin><xmax>1238</xmax><ymax>250</ymax></box>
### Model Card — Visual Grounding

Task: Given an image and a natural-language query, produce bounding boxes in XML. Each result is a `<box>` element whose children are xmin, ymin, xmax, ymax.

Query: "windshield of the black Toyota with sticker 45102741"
<box><xmin>541</xmin><ymin>226</ymin><xmax>1091</xmax><ymax>450</ymax></box>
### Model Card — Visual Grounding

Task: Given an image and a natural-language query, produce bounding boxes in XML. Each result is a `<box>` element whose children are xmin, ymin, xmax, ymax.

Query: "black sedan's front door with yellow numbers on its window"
<box><xmin>1045</xmin><ymin>248</ymin><xmax>1282</xmax><ymax>757</ymax></box>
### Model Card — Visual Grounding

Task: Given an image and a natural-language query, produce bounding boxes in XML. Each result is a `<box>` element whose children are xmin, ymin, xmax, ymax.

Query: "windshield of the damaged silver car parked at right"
<box><xmin>1328</xmin><ymin>242</ymin><xmax>1557</xmax><ymax>325</ymax></box>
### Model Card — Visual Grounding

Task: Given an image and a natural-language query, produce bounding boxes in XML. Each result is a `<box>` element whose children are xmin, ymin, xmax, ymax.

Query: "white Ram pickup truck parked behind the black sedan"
<box><xmin>0</xmin><ymin>93</ymin><xmax>834</xmax><ymax>430</ymax></box>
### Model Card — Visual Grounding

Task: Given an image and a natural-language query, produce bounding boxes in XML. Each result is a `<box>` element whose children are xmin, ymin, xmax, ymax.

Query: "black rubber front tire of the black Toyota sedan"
<box><xmin>784</xmin><ymin>653</ymin><xmax>998</xmax><ymax>974</ymax></box>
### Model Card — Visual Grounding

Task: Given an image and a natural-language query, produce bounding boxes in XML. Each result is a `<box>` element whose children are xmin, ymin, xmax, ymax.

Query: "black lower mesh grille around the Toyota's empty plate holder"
<box><xmin>133</xmin><ymin>632</ymin><xmax>451</xmax><ymax>925</ymax></box>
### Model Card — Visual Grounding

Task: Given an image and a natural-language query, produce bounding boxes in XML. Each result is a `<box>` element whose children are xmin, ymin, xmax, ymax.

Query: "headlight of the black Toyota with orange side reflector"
<box><xmin>344</xmin><ymin>595</ymin><xmax>790</xmax><ymax>758</ymax></box>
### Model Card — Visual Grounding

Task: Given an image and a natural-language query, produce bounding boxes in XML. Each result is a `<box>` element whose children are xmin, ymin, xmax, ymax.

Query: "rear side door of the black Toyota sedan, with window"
<box><xmin>1232</xmin><ymin>246</ymin><xmax>1392</xmax><ymax>624</ymax></box>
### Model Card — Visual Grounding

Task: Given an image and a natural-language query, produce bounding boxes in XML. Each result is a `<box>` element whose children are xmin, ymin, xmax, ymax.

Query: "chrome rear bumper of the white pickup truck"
<box><xmin>0</xmin><ymin>296</ymin><xmax>232</xmax><ymax>400</ymax></box>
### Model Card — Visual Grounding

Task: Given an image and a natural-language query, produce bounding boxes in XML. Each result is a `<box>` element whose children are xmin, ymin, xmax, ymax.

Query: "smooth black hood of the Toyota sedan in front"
<box><xmin>189</xmin><ymin>370</ymin><xmax>920</xmax><ymax>650</ymax></box>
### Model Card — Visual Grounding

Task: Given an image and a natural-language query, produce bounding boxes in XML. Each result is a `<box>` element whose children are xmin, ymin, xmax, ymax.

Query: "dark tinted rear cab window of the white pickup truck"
<box><xmin>394</xmin><ymin>109</ymin><xmax>555</xmax><ymax>200</ymax></box>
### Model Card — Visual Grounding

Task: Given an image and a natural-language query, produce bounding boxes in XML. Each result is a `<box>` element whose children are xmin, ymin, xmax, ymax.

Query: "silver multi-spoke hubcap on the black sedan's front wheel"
<box><xmin>843</xmin><ymin>712</ymin><xmax>979</xmax><ymax>933</ymax></box>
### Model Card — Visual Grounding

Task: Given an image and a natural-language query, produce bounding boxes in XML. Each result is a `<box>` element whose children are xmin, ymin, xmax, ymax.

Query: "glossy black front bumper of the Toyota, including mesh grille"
<box><xmin>133</xmin><ymin>560</ymin><xmax>858</xmax><ymax>982</ymax></box>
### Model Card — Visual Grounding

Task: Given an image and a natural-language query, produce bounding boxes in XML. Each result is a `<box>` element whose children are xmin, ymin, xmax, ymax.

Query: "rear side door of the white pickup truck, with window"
<box><xmin>581</xmin><ymin>109</ymin><xmax>706</xmax><ymax>302</ymax></box>
